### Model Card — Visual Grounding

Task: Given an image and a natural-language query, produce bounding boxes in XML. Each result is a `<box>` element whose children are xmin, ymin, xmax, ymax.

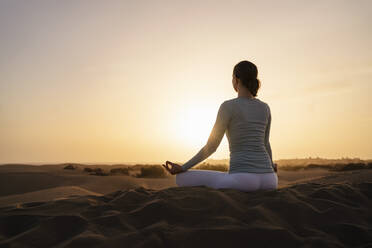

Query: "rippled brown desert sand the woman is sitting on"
<box><xmin>0</xmin><ymin>165</ymin><xmax>372</xmax><ymax>247</ymax></box>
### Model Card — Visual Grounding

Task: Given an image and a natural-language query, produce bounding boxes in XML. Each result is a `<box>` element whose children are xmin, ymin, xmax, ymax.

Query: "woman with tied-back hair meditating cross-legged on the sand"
<box><xmin>163</xmin><ymin>60</ymin><xmax>278</xmax><ymax>191</ymax></box>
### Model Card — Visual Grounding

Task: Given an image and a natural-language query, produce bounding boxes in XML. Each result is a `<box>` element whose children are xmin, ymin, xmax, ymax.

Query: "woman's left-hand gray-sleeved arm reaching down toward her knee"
<box><xmin>182</xmin><ymin>101</ymin><xmax>232</xmax><ymax>171</ymax></box>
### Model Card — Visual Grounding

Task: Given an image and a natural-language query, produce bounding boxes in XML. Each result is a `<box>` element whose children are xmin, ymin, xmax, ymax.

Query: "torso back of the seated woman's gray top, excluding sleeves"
<box><xmin>225</xmin><ymin>97</ymin><xmax>274</xmax><ymax>173</ymax></box>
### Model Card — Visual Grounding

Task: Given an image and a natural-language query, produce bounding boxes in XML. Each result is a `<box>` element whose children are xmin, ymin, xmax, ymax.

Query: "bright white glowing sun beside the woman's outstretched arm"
<box><xmin>174</xmin><ymin>104</ymin><xmax>218</xmax><ymax>147</ymax></box>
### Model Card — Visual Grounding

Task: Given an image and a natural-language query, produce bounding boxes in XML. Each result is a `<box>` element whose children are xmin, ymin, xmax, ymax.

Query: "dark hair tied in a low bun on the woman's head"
<box><xmin>234</xmin><ymin>60</ymin><xmax>261</xmax><ymax>96</ymax></box>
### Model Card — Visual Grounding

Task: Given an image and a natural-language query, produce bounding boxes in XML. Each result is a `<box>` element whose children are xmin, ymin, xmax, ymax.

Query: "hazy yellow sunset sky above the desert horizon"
<box><xmin>0</xmin><ymin>0</ymin><xmax>372</xmax><ymax>163</ymax></box>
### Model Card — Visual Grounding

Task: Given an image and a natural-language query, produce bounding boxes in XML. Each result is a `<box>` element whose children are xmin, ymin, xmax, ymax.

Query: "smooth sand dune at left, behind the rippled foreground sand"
<box><xmin>0</xmin><ymin>166</ymin><xmax>175</xmax><ymax>199</ymax></box>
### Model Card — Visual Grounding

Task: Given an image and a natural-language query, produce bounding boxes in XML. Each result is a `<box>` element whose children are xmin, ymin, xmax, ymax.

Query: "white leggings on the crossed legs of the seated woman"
<box><xmin>176</xmin><ymin>169</ymin><xmax>278</xmax><ymax>191</ymax></box>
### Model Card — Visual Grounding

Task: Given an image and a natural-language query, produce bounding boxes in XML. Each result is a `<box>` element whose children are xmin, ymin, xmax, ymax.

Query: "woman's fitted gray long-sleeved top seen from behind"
<box><xmin>182</xmin><ymin>97</ymin><xmax>274</xmax><ymax>173</ymax></box>
